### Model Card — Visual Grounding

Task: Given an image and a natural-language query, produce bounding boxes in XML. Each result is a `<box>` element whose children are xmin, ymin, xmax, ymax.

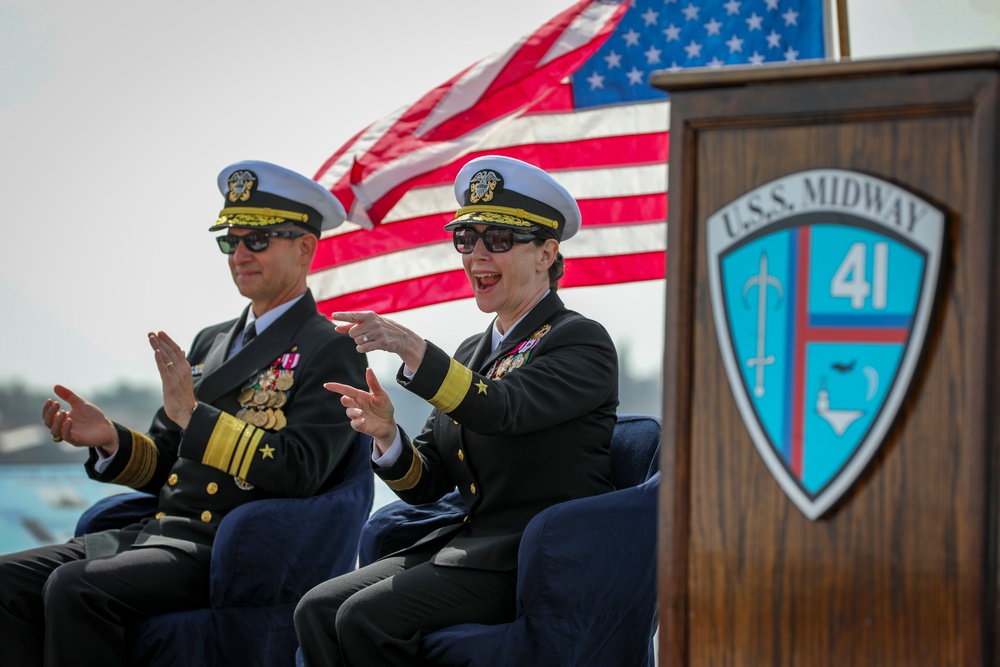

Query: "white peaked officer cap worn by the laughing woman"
<box><xmin>444</xmin><ymin>155</ymin><xmax>580</xmax><ymax>241</ymax></box>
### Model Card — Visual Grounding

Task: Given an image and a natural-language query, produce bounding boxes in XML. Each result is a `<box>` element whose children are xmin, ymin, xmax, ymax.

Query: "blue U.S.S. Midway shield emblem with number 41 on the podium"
<box><xmin>707</xmin><ymin>169</ymin><xmax>945</xmax><ymax>520</ymax></box>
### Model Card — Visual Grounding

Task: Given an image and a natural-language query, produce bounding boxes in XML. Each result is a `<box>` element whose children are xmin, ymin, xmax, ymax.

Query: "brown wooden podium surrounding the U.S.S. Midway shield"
<box><xmin>653</xmin><ymin>51</ymin><xmax>1000</xmax><ymax>667</ymax></box>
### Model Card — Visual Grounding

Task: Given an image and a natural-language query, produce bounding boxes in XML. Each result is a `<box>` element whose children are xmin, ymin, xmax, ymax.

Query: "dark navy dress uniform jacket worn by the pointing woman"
<box><xmin>375</xmin><ymin>292</ymin><xmax>618</xmax><ymax>571</ymax></box>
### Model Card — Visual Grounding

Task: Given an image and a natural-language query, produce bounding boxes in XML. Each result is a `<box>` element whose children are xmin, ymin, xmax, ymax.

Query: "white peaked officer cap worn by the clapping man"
<box><xmin>208</xmin><ymin>160</ymin><xmax>347</xmax><ymax>236</ymax></box>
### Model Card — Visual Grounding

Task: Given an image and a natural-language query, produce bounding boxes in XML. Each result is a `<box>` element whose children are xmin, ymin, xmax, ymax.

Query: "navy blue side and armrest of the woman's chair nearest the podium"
<box><xmin>421</xmin><ymin>472</ymin><xmax>660</xmax><ymax>667</ymax></box>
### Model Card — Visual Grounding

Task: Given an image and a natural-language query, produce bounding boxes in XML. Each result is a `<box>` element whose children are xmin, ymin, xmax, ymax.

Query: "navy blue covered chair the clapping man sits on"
<box><xmin>76</xmin><ymin>436</ymin><xmax>374</xmax><ymax>667</ymax></box>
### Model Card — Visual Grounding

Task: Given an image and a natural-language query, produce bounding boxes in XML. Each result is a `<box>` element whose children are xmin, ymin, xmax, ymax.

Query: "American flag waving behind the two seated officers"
<box><xmin>309</xmin><ymin>0</ymin><xmax>826</xmax><ymax>314</ymax></box>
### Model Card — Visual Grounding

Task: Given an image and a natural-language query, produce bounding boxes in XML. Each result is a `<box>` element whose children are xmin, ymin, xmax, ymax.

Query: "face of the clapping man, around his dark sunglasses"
<box><xmin>226</xmin><ymin>226</ymin><xmax>315</xmax><ymax>317</ymax></box>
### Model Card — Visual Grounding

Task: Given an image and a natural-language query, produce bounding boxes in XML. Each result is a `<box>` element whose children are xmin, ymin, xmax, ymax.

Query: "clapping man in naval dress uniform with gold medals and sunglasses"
<box><xmin>0</xmin><ymin>161</ymin><xmax>366</xmax><ymax>667</ymax></box>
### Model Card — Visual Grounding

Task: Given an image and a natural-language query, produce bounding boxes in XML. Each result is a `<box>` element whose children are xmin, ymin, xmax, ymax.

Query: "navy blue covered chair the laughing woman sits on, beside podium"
<box><xmin>348</xmin><ymin>415</ymin><xmax>660</xmax><ymax>667</ymax></box>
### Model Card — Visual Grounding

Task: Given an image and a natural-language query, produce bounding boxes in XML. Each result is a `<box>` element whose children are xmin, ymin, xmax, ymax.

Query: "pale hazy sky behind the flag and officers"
<box><xmin>0</xmin><ymin>0</ymin><xmax>1000</xmax><ymax>391</ymax></box>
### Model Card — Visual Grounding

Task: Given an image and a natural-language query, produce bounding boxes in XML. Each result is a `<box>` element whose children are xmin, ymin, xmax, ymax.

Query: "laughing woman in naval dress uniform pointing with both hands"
<box><xmin>295</xmin><ymin>156</ymin><xmax>618</xmax><ymax>667</ymax></box>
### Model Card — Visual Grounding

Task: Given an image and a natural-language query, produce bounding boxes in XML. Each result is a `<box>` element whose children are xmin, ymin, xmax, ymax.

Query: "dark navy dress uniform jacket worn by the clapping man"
<box><xmin>79</xmin><ymin>292</ymin><xmax>366</xmax><ymax>559</ymax></box>
